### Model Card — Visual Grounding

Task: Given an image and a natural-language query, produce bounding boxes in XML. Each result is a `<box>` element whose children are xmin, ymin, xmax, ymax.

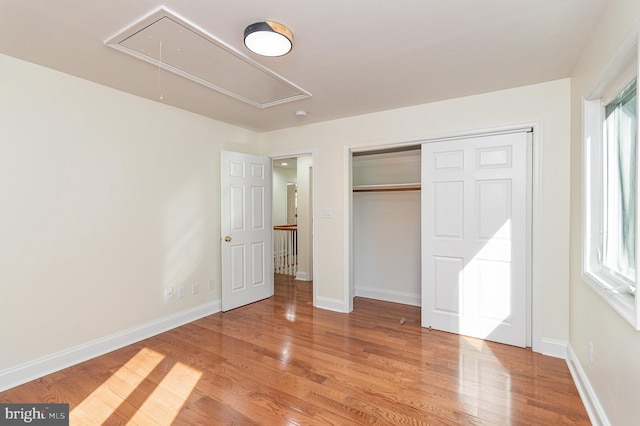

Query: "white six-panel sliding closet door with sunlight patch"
<box><xmin>422</xmin><ymin>132</ymin><xmax>528</xmax><ymax>347</ymax></box>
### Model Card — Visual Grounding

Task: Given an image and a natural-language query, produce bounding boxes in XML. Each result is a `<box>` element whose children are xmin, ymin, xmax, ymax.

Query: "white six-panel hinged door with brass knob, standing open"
<box><xmin>221</xmin><ymin>151</ymin><xmax>273</xmax><ymax>311</ymax></box>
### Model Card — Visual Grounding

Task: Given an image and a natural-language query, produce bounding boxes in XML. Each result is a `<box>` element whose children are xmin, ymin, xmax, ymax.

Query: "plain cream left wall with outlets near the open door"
<box><xmin>0</xmin><ymin>55</ymin><xmax>258</xmax><ymax>388</ymax></box>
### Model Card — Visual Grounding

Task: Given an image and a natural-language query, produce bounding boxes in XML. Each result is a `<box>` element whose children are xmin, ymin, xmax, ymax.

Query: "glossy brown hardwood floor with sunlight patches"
<box><xmin>0</xmin><ymin>276</ymin><xmax>589</xmax><ymax>426</ymax></box>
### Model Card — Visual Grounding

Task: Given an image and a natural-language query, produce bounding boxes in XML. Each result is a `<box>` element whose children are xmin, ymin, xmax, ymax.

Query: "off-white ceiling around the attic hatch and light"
<box><xmin>0</xmin><ymin>0</ymin><xmax>607</xmax><ymax>132</ymax></box>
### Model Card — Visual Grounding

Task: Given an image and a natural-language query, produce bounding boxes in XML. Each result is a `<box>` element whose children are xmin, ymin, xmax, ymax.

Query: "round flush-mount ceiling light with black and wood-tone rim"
<box><xmin>244</xmin><ymin>21</ymin><xmax>293</xmax><ymax>56</ymax></box>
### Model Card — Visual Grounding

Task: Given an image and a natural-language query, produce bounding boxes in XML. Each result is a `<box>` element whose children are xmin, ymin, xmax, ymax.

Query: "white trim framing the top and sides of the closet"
<box><xmin>344</xmin><ymin>121</ymin><xmax>544</xmax><ymax>357</ymax></box>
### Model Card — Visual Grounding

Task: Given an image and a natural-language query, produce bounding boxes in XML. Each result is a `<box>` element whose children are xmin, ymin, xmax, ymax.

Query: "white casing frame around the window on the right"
<box><xmin>582</xmin><ymin>36</ymin><xmax>640</xmax><ymax>330</ymax></box>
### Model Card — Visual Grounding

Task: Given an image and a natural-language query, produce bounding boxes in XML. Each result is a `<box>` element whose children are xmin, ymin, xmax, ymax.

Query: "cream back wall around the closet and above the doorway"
<box><xmin>261</xmin><ymin>79</ymin><xmax>570</xmax><ymax>350</ymax></box>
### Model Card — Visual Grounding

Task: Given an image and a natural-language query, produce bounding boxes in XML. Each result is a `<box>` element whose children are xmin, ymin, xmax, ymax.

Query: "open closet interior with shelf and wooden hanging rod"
<box><xmin>351</xmin><ymin>145</ymin><xmax>421</xmax><ymax>306</ymax></box>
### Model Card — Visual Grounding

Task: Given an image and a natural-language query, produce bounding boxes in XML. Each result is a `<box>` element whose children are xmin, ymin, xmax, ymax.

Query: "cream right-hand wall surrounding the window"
<box><xmin>570</xmin><ymin>0</ymin><xmax>640</xmax><ymax>425</ymax></box>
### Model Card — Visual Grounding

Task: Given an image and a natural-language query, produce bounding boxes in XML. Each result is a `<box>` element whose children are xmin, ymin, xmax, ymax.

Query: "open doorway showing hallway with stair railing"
<box><xmin>272</xmin><ymin>155</ymin><xmax>313</xmax><ymax>282</ymax></box>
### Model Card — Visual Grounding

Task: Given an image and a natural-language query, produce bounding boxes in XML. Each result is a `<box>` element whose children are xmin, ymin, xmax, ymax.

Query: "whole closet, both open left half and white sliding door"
<box><xmin>347</xmin><ymin>127</ymin><xmax>540</xmax><ymax>350</ymax></box>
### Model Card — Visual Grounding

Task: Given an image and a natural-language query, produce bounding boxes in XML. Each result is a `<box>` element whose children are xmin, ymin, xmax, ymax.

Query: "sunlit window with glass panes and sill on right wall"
<box><xmin>583</xmin><ymin>76</ymin><xmax>640</xmax><ymax>330</ymax></box>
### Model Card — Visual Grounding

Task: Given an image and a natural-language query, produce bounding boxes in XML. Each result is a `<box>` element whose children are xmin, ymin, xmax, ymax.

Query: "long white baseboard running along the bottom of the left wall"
<box><xmin>0</xmin><ymin>301</ymin><xmax>222</xmax><ymax>392</ymax></box>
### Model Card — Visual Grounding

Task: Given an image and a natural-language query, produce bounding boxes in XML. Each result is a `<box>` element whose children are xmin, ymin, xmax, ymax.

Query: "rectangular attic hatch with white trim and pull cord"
<box><xmin>104</xmin><ymin>7</ymin><xmax>311</xmax><ymax>108</ymax></box>
